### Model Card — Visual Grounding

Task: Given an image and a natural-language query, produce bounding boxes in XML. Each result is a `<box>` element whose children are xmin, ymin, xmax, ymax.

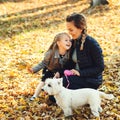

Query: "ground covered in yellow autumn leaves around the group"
<box><xmin>0</xmin><ymin>0</ymin><xmax>120</xmax><ymax>120</ymax></box>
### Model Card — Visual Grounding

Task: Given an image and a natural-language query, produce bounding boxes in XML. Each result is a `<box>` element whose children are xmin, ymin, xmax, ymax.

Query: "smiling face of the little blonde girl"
<box><xmin>57</xmin><ymin>35</ymin><xmax>72</xmax><ymax>50</ymax></box>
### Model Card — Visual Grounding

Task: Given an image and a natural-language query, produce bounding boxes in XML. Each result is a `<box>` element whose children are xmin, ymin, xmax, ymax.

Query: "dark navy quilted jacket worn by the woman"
<box><xmin>70</xmin><ymin>36</ymin><xmax>104</xmax><ymax>84</ymax></box>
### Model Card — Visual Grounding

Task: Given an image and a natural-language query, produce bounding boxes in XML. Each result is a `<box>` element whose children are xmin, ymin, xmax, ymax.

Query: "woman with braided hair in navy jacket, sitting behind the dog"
<box><xmin>63</xmin><ymin>13</ymin><xmax>104</xmax><ymax>89</ymax></box>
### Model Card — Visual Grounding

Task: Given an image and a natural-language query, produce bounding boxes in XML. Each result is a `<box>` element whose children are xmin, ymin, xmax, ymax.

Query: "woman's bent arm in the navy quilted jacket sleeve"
<box><xmin>79</xmin><ymin>37</ymin><xmax>104</xmax><ymax>77</ymax></box>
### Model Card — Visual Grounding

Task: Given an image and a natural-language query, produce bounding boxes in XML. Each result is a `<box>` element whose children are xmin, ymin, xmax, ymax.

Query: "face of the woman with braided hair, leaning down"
<box><xmin>66</xmin><ymin>22</ymin><xmax>82</xmax><ymax>39</ymax></box>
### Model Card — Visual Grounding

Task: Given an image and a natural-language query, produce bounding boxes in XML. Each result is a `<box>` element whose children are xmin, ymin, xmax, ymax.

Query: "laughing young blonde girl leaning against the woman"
<box><xmin>28</xmin><ymin>32</ymin><xmax>72</xmax><ymax>101</ymax></box>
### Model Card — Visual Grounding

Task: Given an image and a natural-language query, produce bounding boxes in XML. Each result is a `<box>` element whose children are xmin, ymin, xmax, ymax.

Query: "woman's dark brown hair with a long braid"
<box><xmin>66</xmin><ymin>13</ymin><xmax>87</xmax><ymax>50</ymax></box>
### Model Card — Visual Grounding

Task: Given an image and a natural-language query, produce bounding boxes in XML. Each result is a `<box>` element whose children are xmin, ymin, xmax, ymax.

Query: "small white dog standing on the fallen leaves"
<box><xmin>42</xmin><ymin>78</ymin><xmax>114</xmax><ymax>117</ymax></box>
